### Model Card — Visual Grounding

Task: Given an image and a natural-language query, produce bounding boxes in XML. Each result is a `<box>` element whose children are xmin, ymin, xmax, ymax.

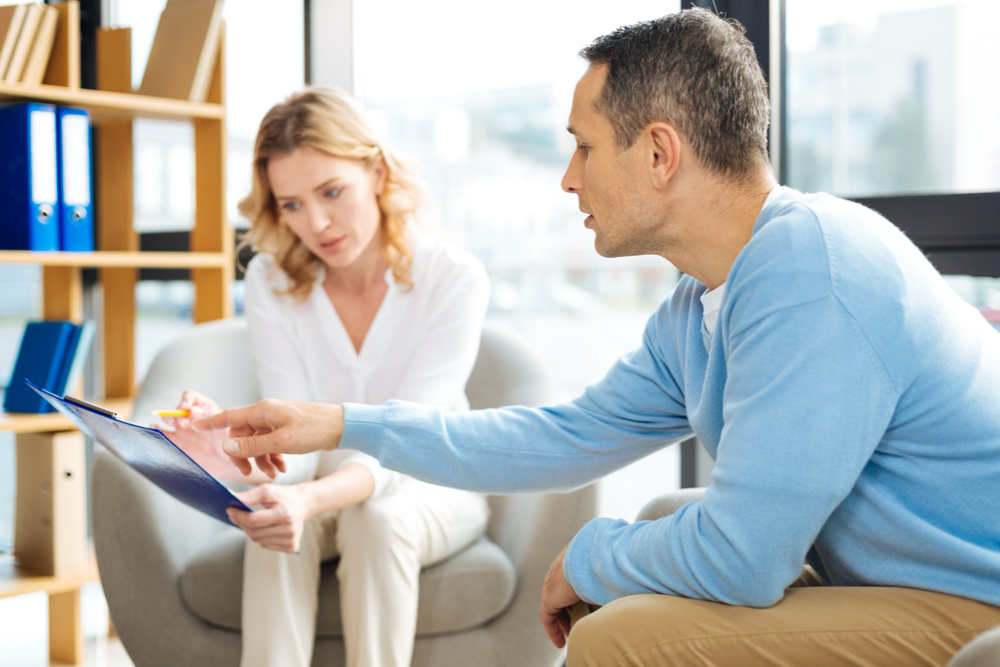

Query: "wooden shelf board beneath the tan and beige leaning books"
<box><xmin>0</xmin><ymin>82</ymin><xmax>226</xmax><ymax>122</ymax></box>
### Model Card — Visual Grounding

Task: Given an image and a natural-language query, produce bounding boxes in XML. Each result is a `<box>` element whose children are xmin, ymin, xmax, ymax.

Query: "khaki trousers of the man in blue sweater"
<box><xmin>567</xmin><ymin>586</ymin><xmax>1000</xmax><ymax>667</ymax></box>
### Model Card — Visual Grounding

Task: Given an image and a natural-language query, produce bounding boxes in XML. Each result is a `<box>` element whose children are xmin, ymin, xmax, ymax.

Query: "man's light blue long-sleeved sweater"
<box><xmin>342</xmin><ymin>188</ymin><xmax>1000</xmax><ymax>607</ymax></box>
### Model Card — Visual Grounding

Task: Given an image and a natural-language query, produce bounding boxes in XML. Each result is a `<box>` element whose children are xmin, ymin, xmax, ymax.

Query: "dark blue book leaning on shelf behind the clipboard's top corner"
<box><xmin>3</xmin><ymin>320</ymin><xmax>76</xmax><ymax>413</ymax></box>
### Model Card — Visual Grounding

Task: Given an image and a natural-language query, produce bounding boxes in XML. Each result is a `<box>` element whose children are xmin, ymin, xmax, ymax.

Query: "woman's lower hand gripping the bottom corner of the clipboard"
<box><xmin>226</xmin><ymin>484</ymin><xmax>313</xmax><ymax>554</ymax></box>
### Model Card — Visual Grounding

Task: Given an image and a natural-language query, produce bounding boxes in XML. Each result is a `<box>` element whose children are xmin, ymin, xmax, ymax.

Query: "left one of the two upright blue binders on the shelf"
<box><xmin>0</xmin><ymin>102</ymin><xmax>59</xmax><ymax>250</ymax></box>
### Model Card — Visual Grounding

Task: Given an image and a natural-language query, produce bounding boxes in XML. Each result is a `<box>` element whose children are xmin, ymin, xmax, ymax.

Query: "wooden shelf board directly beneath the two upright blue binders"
<box><xmin>0</xmin><ymin>250</ymin><xmax>232</xmax><ymax>269</ymax></box>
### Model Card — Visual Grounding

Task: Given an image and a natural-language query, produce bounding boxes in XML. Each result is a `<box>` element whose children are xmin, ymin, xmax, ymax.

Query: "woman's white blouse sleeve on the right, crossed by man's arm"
<box><xmin>340</xmin><ymin>253</ymin><xmax>490</xmax><ymax>498</ymax></box>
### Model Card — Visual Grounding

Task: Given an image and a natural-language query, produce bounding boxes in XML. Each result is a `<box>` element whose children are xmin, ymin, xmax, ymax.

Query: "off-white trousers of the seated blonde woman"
<box><xmin>241</xmin><ymin>479</ymin><xmax>489</xmax><ymax>667</ymax></box>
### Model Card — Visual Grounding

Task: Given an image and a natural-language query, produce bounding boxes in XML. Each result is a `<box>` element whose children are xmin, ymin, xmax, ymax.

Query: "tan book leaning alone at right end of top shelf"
<box><xmin>139</xmin><ymin>0</ymin><xmax>223</xmax><ymax>102</ymax></box>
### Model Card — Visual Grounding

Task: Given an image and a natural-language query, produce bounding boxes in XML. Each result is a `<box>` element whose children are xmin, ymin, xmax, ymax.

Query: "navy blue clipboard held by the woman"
<box><xmin>25</xmin><ymin>379</ymin><xmax>251</xmax><ymax>525</ymax></box>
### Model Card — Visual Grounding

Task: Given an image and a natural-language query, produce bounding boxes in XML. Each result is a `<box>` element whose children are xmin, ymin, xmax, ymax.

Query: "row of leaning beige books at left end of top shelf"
<box><xmin>0</xmin><ymin>3</ymin><xmax>59</xmax><ymax>85</ymax></box>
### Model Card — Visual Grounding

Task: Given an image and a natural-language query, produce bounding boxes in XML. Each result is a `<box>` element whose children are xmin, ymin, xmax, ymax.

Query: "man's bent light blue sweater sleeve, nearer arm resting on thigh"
<box><xmin>563</xmin><ymin>292</ymin><xmax>896</xmax><ymax>607</ymax></box>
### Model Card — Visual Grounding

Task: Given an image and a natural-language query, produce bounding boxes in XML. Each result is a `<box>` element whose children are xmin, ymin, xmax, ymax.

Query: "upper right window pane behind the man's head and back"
<box><xmin>786</xmin><ymin>0</ymin><xmax>1000</xmax><ymax>196</ymax></box>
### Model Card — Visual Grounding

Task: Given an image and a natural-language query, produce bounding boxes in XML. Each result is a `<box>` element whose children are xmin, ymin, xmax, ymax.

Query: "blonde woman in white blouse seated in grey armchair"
<box><xmin>162</xmin><ymin>88</ymin><xmax>489</xmax><ymax>666</ymax></box>
